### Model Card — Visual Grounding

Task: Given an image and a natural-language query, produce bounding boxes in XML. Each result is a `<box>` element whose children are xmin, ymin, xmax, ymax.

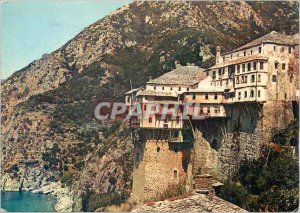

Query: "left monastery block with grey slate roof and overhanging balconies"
<box><xmin>125</xmin><ymin>66</ymin><xmax>206</xmax><ymax>129</ymax></box>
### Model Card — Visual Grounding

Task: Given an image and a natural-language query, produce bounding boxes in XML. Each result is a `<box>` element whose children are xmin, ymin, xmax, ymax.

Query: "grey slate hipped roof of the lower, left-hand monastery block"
<box><xmin>147</xmin><ymin>66</ymin><xmax>206</xmax><ymax>86</ymax></box>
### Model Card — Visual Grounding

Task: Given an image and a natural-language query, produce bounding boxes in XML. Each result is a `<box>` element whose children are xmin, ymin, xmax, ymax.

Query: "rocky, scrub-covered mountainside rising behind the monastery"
<box><xmin>1</xmin><ymin>2</ymin><xmax>298</xmax><ymax>210</ymax></box>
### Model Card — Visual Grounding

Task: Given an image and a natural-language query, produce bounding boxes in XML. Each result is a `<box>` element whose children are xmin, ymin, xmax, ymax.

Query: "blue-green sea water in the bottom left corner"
<box><xmin>1</xmin><ymin>191</ymin><xmax>55</xmax><ymax>212</ymax></box>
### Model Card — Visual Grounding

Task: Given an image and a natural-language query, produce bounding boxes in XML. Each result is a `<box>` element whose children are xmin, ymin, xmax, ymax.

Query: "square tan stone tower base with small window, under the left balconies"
<box><xmin>132</xmin><ymin>140</ymin><xmax>190</xmax><ymax>202</ymax></box>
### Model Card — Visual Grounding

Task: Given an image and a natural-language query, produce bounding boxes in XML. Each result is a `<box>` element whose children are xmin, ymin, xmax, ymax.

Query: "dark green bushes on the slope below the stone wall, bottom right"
<box><xmin>219</xmin><ymin>120</ymin><xmax>299</xmax><ymax>212</ymax></box>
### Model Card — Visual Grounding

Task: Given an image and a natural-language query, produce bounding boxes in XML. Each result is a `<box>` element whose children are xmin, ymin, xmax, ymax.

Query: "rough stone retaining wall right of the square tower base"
<box><xmin>193</xmin><ymin>101</ymin><xmax>294</xmax><ymax>181</ymax></box>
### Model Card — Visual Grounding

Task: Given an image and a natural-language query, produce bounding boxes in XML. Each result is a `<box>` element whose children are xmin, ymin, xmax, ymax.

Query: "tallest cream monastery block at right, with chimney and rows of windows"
<box><xmin>206</xmin><ymin>31</ymin><xmax>299</xmax><ymax>103</ymax></box>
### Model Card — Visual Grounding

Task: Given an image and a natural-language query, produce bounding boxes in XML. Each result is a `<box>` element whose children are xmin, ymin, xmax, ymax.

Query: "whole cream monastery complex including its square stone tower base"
<box><xmin>125</xmin><ymin>32</ymin><xmax>299</xmax><ymax>201</ymax></box>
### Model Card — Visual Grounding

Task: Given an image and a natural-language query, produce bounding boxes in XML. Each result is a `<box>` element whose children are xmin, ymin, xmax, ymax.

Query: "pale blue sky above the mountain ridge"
<box><xmin>0</xmin><ymin>0</ymin><xmax>131</xmax><ymax>79</ymax></box>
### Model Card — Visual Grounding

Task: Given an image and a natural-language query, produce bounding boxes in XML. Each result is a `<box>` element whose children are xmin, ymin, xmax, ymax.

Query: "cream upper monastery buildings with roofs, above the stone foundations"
<box><xmin>126</xmin><ymin>31</ymin><xmax>299</xmax><ymax>129</ymax></box>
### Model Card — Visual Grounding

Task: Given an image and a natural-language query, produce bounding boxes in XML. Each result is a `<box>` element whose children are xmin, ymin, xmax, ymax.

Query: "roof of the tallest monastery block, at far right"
<box><xmin>222</xmin><ymin>31</ymin><xmax>299</xmax><ymax>55</ymax></box>
